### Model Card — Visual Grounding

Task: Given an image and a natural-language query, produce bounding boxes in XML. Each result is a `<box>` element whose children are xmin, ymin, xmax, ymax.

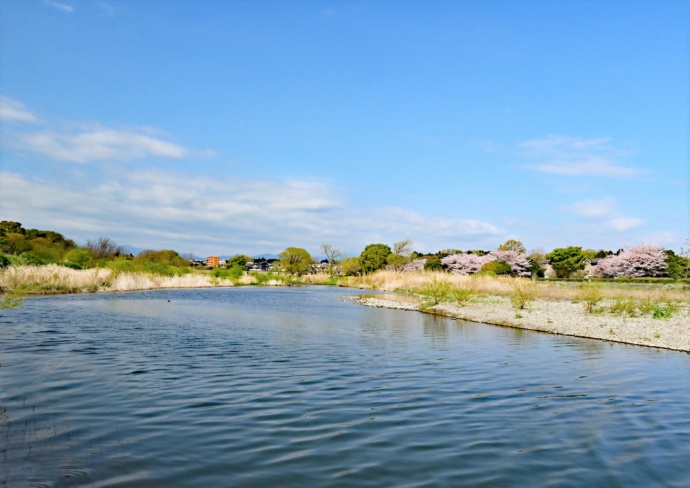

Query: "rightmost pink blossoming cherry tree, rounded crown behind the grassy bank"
<box><xmin>594</xmin><ymin>244</ymin><xmax>668</xmax><ymax>278</ymax></box>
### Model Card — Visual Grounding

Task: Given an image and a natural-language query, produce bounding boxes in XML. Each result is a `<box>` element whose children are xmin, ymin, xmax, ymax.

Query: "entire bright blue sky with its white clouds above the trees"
<box><xmin>0</xmin><ymin>0</ymin><xmax>690</xmax><ymax>255</ymax></box>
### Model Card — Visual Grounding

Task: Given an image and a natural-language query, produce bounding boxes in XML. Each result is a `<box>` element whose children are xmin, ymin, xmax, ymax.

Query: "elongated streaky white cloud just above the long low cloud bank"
<box><xmin>14</xmin><ymin>127</ymin><xmax>190</xmax><ymax>163</ymax></box>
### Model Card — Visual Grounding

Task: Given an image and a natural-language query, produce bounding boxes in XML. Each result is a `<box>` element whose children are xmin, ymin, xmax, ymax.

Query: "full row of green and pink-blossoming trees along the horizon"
<box><xmin>0</xmin><ymin>221</ymin><xmax>690</xmax><ymax>279</ymax></box>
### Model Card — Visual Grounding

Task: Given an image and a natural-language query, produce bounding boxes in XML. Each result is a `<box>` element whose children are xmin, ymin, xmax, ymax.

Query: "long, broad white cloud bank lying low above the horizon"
<box><xmin>0</xmin><ymin>171</ymin><xmax>502</xmax><ymax>254</ymax></box>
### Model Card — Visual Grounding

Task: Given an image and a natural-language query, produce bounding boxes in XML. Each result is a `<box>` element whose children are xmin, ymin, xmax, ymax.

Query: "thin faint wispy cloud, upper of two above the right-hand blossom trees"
<box><xmin>520</xmin><ymin>136</ymin><xmax>646</xmax><ymax>178</ymax></box>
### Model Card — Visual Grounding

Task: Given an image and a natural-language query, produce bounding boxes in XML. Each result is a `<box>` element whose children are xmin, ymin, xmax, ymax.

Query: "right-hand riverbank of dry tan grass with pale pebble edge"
<box><xmin>343</xmin><ymin>272</ymin><xmax>690</xmax><ymax>352</ymax></box>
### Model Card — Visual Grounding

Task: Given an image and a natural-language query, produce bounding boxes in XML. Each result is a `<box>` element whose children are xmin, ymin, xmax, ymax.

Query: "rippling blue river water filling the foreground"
<box><xmin>0</xmin><ymin>287</ymin><xmax>690</xmax><ymax>487</ymax></box>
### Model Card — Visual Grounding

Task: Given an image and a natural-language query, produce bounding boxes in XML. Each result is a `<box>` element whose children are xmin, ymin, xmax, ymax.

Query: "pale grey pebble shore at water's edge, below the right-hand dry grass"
<box><xmin>353</xmin><ymin>295</ymin><xmax>690</xmax><ymax>352</ymax></box>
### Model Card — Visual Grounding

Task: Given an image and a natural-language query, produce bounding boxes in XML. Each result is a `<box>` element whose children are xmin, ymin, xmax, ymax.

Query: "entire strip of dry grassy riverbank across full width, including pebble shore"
<box><xmin>0</xmin><ymin>265</ymin><xmax>690</xmax><ymax>351</ymax></box>
